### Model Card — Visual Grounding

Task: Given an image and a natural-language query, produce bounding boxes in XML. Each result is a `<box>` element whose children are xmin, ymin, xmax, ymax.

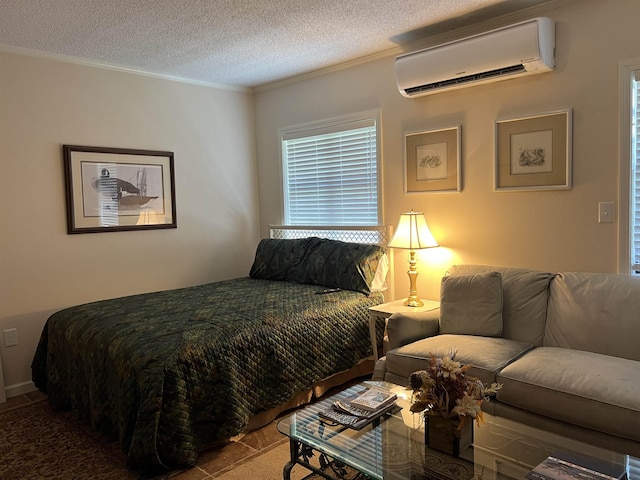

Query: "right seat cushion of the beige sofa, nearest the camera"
<box><xmin>497</xmin><ymin>347</ymin><xmax>640</xmax><ymax>441</ymax></box>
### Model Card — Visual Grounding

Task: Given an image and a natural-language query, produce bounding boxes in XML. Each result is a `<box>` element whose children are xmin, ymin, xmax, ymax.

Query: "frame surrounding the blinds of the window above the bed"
<box><xmin>278</xmin><ymin>109</ymin><xmax>383</xmax><ymax>227</ymax></box>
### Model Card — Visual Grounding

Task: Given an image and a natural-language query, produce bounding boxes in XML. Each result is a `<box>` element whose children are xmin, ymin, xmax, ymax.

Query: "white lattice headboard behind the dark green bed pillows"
<box><xmin>269</xmin><ymin>225</ymin><xmax>391</xmax><ymax>247</ymax></box>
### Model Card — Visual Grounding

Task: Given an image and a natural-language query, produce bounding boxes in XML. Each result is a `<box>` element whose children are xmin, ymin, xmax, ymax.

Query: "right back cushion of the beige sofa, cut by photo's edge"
<box><xmin>544</xmin><ymin>272</ymin><xmax>640</xmax><ymax>360</ymax></box>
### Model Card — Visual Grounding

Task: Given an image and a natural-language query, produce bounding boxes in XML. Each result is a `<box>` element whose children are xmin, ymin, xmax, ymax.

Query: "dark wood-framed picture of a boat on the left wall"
<box><xmin>63</xmin><ymin>145</ymin><xmax>177</xmax><ymax>234</ymax></box>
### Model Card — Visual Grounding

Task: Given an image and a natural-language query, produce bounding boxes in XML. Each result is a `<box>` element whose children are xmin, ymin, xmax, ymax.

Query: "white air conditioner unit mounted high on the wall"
<box><xmin>395</xmin><ymin>17</ymin><xmax>555</xmax><ymax>97</ymax></box>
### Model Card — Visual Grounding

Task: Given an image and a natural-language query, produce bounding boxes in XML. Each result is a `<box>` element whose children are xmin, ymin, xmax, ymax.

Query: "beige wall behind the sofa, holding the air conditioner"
<box><xmin>256</xmin><ymin>0</ymin><xmax>640</xmax><ymax>299</ymax></box>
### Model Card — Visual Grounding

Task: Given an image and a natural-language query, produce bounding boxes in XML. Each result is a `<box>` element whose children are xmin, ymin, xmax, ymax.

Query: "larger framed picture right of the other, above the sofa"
<box><xmin>494</xmin><ymin>109</ymin><xmax>572</xmax><ymax>191</ymax></box>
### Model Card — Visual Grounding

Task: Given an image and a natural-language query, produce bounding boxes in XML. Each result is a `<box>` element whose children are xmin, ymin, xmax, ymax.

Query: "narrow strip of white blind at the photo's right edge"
<box><xmin>629</xmin><ymin>70</ymin><xmax>640</xmax><ymax>275</ymax></box>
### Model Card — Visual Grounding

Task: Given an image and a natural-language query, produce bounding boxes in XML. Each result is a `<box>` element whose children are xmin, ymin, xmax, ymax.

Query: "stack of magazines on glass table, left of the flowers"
<box><xmin>318</xmin><ymin>387</ymin><xmax>397</xmax><ymax>430</ymax></box>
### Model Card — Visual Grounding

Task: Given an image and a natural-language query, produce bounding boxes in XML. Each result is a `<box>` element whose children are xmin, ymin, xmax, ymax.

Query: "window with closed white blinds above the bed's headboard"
<box><xmin>281</xmin><ymin>112</ymin><xmax>380</xmax><ymax>225</ymax></box>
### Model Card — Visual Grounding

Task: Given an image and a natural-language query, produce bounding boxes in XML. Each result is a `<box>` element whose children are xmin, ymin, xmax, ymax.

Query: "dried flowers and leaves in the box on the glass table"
<box><xmin>409</xmin><ymin>351</ymin><xmax>502</xmax><ymax>426</ymax></box>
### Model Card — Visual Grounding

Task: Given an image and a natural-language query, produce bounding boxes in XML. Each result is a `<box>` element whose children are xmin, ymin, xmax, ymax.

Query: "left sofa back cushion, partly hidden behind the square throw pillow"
<box><xmin>449</xmin><ymin>265</ymin><xmax>554</xmax><ymax>346</ymax></box>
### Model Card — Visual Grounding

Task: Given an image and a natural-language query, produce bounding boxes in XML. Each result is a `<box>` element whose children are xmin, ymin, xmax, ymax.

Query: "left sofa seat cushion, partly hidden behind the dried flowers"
<box><xmin>386</xmin><ymin>335</ymin><xmax>533</xmax><ymax>385</ymax></box>
